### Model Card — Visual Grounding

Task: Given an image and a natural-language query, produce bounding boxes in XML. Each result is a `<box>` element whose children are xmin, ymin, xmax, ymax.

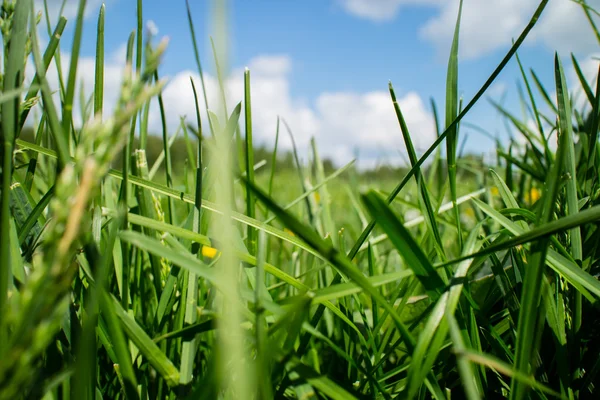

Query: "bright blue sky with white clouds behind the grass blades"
<box><xmin>36</xmin><ymin>0</ymin><xmax>600</xmax><ymax>166</ymax></box>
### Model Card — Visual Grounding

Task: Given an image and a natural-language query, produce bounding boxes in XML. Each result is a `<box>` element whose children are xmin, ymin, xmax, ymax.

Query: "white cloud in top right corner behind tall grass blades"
<box><xmin>419</xmin><ymin>0</ymin><xmax>600</xmax><ymax>59</ymax></box>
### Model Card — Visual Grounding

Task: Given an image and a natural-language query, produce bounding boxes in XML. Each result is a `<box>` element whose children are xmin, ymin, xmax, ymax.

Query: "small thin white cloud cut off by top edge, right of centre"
<box><xmin>336</xmin><ymin>0</ymin><xmax>442</xmax><ymax>22</ymax></box>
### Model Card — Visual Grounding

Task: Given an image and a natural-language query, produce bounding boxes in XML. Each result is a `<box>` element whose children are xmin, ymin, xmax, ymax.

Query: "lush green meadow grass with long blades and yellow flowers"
<box><xmin>0</xmin><ymin>0</ymin><xmax>600</xmax><ymax>400</ymax></box>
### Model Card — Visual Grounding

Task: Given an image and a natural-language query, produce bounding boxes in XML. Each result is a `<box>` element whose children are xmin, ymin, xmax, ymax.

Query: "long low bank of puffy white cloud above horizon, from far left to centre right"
<box><xmin>28</xmin><ymin>38</ymin><xmax>435</xmax><ymax>166</ymax></box>
